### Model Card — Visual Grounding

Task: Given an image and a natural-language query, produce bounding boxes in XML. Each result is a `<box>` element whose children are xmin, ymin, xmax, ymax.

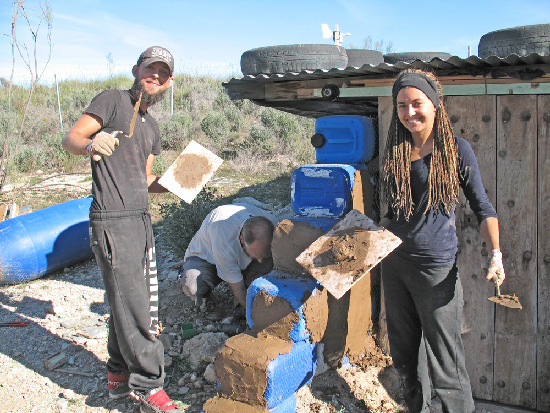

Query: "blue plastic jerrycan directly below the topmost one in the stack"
<box><xmin>290</xmin><ymin>164</ymin><xmax>365</xmax><ymax>218</ymax></box>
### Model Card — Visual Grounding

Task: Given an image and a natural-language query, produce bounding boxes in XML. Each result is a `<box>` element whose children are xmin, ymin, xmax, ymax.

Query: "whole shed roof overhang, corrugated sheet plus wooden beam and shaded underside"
<box><xmin>223</xmin><ymin>53</ymin><xmax>550</xmax><ymax>118</ymax></box>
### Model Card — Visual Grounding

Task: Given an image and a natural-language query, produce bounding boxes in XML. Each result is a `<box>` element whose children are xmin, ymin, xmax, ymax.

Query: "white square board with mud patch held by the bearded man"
<box><xmin>158</xmin><ymin>141</ymin><xmax>223</xmax><ymax>204</ymax></box>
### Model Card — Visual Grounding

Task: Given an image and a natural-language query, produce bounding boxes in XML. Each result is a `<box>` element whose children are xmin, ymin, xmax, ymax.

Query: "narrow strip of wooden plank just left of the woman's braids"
<box><xmin>377</xmin><ymin>97</ymin><xmax>393</xmax><ymax>353</ymax></box>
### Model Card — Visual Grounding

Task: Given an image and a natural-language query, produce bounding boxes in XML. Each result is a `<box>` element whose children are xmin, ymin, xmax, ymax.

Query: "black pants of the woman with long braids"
<box><xmin>382</xmin><ymin>253</ymin><xmax>475</xmax><ymax>413</ymax></box>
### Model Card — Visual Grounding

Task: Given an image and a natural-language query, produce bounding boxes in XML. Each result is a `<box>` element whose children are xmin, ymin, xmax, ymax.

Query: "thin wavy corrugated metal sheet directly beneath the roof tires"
<box><xmin>224</xmin><ymin>53</ymin><xmax>550</xmax><ymax>86</ymax></box>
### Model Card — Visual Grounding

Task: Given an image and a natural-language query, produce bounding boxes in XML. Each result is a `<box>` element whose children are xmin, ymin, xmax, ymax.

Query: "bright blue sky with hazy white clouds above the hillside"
<box><xmin>0</xmin><ymin>0</ymin><xmax>550</xmax><ymax>85</ymax></box>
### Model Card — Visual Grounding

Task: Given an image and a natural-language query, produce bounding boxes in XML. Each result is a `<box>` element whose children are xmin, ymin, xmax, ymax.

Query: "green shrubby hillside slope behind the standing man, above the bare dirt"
<box><xmin>0</xmin><ymin>75</ymin><xmax>314</xmax><ymax>180</ymax></box>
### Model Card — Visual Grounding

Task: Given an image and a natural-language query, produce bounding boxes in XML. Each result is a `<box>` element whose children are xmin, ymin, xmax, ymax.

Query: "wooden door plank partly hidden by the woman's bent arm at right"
<box><xmin>446</xmin><ymin>96</ymin><xmax>496</xmax><ymax>400</ymax></box>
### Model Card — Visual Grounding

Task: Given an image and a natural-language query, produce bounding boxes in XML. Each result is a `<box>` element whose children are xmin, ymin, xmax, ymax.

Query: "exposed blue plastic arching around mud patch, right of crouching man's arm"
<box><xmin>246</xmin><ymin>271</ymin><xmax>322</xmax><ymax>342</ymax></box>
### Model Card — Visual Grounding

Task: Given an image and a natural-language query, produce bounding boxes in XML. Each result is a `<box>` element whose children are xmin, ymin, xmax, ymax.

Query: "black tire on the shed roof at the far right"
<box><xmin>477</xmin><ymin>24</ymin><xmax>550</xmax><ymax>59</ymax></box>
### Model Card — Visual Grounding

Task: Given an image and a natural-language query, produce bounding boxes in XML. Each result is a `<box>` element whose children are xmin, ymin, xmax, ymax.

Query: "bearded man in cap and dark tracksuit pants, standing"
<box><xmin>62</xmin><ymin>46</ymin><xmax>180</xmax><ymax>413</ymax></box>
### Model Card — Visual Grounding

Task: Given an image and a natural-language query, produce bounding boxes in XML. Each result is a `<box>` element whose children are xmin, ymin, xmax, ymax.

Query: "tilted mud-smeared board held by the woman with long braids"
<box><xmin>296</xmin><ymin>209</ymin><xmax>401</xmax><ymax>298</ymax></box>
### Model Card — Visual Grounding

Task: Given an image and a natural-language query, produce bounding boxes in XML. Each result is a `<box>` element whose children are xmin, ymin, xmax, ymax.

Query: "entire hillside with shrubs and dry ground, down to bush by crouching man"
<box><xmin>0</xmin><ymin>75</ymin><xmax>315</xmax><ymax>251</ymax></box>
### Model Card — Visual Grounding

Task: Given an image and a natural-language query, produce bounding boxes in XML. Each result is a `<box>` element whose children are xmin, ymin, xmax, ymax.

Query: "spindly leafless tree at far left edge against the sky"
<box><xmin>0</xmin><ymin>0</ymin><xmax>52</xmax><ymax>191</ymax></box>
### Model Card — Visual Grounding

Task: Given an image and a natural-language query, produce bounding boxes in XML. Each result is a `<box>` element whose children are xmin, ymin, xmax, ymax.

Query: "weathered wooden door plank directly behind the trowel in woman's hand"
<box><xmin>493</xmin><ymin>96</ymin><xmax>537</xmax><ymax>408</ymax></box>
